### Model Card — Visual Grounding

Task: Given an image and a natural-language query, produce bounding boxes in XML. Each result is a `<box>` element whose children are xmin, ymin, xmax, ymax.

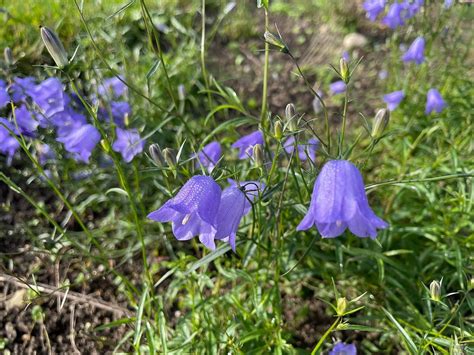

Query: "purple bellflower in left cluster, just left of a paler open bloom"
<box><xmin>56</xmin><ymin>123</ymin><xmax>100</xmax><ymax>163</ymax></box>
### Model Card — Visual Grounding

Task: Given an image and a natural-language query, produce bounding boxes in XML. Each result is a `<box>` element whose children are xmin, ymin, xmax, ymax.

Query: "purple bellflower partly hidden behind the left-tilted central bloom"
<box><xmin>216</xmin><ymin>180</ymin><xmax>265</xmax><ymax>251</ymax></box>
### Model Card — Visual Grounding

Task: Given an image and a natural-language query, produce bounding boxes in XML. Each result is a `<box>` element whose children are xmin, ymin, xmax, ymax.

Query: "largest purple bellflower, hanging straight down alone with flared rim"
<box><xmin>296</xmin><ymin>160</ymin><xmax>388</xmax><ymax>239</ymax></box>
